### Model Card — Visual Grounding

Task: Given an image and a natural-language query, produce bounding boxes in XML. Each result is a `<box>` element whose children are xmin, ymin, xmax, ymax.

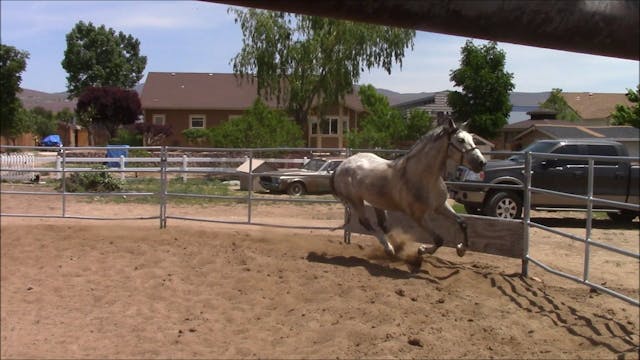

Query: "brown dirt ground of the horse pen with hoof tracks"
<box><xmin>0</xmin><ymin>187</ymin><xmax>640</xmax><ymax>359</ymax></box>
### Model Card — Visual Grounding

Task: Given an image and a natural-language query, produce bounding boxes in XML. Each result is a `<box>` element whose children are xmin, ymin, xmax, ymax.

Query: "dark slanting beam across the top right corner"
<box><xmin>204</xmin><ymin>0</ymin><xmax>640</xmax><ymax>60</ymax></box>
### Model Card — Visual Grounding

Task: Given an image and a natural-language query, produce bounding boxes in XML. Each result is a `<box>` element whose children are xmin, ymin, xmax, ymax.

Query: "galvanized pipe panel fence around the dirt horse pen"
<box><xmin>0</xmin><ymin>145</ymin><xmax>640</xmax><ymax>306</ymax></box>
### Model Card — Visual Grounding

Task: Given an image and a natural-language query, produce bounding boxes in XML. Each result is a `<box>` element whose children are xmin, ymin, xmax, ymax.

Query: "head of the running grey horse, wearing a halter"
<box><xmin>445</xmin><ymin>118</ymin><xmax>487</xmax><ymax>172</ymax></box>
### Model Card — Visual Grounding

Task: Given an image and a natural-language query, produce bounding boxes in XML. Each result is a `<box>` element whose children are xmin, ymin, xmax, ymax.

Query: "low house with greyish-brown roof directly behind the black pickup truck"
<box><xmin>513</xmin><ymin>124</ymin><xmax>640</xmax><ymax>157</ymax></box>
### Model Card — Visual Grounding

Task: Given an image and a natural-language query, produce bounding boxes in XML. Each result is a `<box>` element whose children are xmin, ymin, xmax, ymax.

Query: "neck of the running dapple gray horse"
<box><xmin>397</xmin><ymin>135</ymin><xmax>448</xmax><ymax>182</ymax></box>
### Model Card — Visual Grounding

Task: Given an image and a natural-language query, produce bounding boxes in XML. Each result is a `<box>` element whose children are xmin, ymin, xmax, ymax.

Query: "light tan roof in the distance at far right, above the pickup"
<box><xmin>561</xmin><ymin>92</ymin><xmax>632</xmax><ymax>119</ymax></box>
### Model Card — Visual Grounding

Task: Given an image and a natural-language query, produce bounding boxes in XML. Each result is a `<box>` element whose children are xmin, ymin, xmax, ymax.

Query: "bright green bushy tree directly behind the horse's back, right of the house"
<box><xmin>347</xmin><ymin>85</ymin><xmax>432</xmax><ymax>149</ymax></box>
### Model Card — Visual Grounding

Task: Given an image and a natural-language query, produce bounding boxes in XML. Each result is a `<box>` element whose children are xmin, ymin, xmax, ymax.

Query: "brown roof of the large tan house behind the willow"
<box><xmin>140</xmin><ymin>72</ymin><xmax>363</xmax><ymax>111</ymax></box>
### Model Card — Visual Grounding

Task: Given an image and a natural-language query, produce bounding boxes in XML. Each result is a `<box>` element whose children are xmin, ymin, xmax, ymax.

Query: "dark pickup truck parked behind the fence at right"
<box><xmin>449</xmin><ymin>139</ymin><xmax>640</xmax><ymax>222</ymax></box>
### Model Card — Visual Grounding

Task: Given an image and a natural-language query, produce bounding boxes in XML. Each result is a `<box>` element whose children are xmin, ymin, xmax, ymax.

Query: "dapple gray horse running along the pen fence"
<box><xmin>331</xmin><ymin>119</ymin><xmax>486</xmax><ymax>262</ymax></box>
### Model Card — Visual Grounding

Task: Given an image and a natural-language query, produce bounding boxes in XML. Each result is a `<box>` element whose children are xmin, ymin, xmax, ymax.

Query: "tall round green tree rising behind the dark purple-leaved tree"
<box><xmin>62</xmin><ymin>21</ymin><xmax>147</xmax><ymax>97</ymax></box>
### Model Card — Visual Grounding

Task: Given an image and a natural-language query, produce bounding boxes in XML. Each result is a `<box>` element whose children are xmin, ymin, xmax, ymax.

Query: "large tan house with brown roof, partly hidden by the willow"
<box><xmin>141</xmin><ymin>72</ymin><xmax>364</xmax><ymax>148</ymax></box>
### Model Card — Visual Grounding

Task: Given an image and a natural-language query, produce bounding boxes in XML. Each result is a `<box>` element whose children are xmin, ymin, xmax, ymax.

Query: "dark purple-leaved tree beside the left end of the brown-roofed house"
<box><xmin>76</xmin><ymin>86</ymin><xmax>142</xmax><ymax>138</ymax></box>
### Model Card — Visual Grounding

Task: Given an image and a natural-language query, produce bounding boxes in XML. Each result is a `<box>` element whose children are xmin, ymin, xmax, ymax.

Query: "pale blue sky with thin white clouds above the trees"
<box><xmin>0</xmin><ymin>0</ymin><xmax>640</xmax><ymax>93</ymax></box>
